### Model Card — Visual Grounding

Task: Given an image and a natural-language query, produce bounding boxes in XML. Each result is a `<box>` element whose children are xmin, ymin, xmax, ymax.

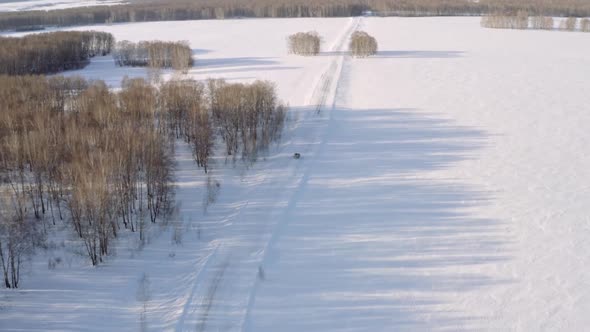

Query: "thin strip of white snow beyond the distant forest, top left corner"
<box><xmin>0</xmin><ymin>0</ymin><xmax>127</xmax><ymax>12</ymax></box>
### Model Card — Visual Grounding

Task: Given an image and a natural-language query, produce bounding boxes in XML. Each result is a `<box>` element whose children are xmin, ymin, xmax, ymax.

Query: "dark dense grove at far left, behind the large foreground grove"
<box><xmin>0</xmin><ymin>31</ymin><xmax>114</xmax><ymax>75</ymax></box>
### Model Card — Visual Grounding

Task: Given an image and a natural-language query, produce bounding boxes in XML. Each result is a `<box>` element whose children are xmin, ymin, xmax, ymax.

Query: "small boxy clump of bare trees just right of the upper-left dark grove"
<box><xmin>113</xmin><ymin>40</ymin><xmax>193</xmax><ymax>71</ymax></box>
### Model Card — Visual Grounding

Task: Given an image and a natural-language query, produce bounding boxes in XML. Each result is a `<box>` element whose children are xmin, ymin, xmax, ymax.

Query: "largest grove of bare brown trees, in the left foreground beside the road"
<box><xmin>0</xmin><ymin>76</ymin><xmax>286</xmax><ymax>288</ymax></box>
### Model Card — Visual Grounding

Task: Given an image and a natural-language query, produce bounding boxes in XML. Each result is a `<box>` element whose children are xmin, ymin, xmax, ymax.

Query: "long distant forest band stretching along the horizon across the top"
<box><xmin>0</xmin><ymin>0</ymin><xmax>590</xmax><ymax>30</ymax></box>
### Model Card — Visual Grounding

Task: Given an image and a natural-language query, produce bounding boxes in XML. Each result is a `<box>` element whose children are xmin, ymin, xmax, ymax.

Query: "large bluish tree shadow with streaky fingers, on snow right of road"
<box><xmin>252</xmin><ymin>109</ymin><xmax>509</xmax><ymax>331</ymax></box>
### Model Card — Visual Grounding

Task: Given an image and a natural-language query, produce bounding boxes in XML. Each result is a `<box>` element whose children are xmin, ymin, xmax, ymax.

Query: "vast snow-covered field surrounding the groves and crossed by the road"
<box><xmin>0</xmin><ymin>18</ymin><xmax>590</xmax><ymax>331</ymax></box>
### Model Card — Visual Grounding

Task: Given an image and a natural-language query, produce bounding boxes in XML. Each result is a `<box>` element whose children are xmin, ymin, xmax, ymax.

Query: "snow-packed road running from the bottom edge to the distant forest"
<box><xmin>175</xmin><ymin>18</ymin><xmax>361</xmax><ymax>331</ymax></box>
